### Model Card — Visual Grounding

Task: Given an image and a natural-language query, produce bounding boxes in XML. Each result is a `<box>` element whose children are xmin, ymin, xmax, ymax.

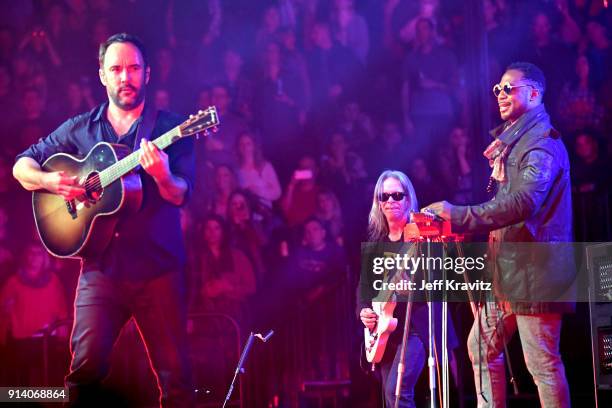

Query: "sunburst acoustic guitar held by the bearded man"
<box><xmin>32</xmin><ymin>106</ymin><xmax>219</xmax><ymax>258</ymax></box>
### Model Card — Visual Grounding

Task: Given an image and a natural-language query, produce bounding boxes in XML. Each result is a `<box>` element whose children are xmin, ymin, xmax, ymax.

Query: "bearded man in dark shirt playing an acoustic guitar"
<box><xmin>13</xmin><ymin>33</ymin><xmax>194</xmax><ymax>407</ymax></box>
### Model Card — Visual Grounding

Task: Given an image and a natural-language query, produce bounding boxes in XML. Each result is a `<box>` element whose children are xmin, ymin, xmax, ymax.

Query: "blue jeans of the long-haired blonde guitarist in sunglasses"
<box><xmin>380</xmin><ymin>335</ymin><xmax>425</xmax><ymax>408</ymax></box>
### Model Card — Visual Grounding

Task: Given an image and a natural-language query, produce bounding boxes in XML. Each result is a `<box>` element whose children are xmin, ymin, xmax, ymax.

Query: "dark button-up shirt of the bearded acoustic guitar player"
<box><xmin>17</xmin><ymin>102</ymin><xmax>195</xmax><ymax>280</ymax></box>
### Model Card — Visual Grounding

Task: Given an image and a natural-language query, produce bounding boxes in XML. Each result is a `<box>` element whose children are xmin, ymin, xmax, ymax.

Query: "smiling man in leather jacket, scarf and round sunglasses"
<box><xmin>427</xmin><ymin>62</ymin><xmax>576</xmax><ymax>407</ymax></box>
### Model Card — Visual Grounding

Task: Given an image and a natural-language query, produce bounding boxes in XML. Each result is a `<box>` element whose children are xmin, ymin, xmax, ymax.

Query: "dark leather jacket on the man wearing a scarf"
<box><xmin>451</xmin><ymin>105</ymin><xmax>576</xmax><ymax>314</ymax></box>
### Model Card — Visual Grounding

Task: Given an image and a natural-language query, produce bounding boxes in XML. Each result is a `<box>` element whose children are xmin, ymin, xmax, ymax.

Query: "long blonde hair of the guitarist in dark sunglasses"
<box><xmin>368</xmin><ymin>170</ymin><xmax>419</xmax><ymax>241</ymax></box>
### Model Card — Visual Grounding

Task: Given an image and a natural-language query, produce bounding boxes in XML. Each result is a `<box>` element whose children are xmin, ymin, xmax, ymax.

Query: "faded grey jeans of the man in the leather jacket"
<box><xmin>468</xmin><ymin>303</ymin><xmax>570</xmax><ymax>408</ymax></box>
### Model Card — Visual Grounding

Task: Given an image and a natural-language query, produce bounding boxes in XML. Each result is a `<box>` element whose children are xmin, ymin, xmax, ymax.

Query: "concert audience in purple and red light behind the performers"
<box><xmin>0</xmin><ymin>0</ymin><xmax>612</xmax><ymax>404</ymax></box>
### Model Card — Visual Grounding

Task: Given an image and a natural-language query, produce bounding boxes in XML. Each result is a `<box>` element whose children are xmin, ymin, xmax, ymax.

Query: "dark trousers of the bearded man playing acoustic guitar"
<box><xmin>66</xmin><ymin>270</ymin><xmax>193</xmax><ymax>407</ymax></box>
